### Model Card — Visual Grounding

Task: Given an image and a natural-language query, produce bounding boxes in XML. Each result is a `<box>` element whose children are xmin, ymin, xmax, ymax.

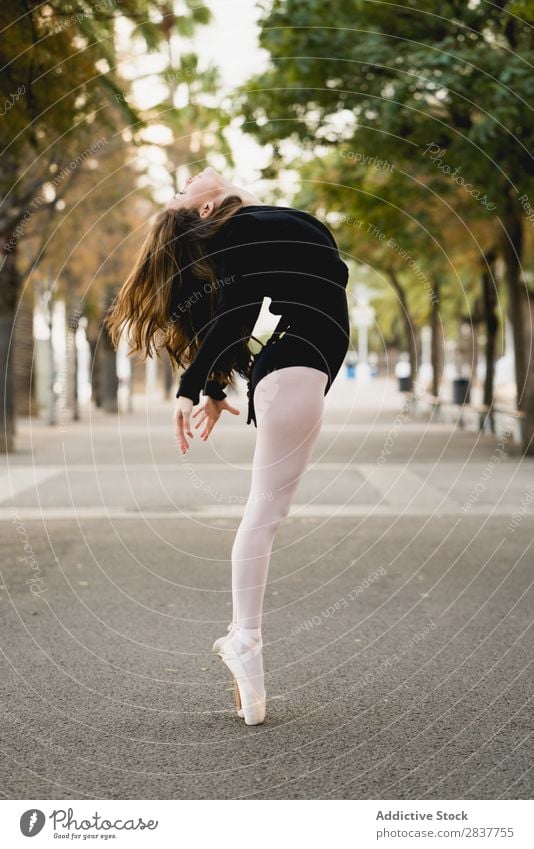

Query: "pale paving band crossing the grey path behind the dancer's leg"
<box><xmin>0</xmin><ymin>464</ymin><xmax>534</xmax><ymax>521</ymax></box>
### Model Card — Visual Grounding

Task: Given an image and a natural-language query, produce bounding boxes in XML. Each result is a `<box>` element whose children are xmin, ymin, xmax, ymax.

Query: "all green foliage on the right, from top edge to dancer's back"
<box><xmin>236</xmin><ymin>0</ymin><xmax>534</xmax><ymax>348</ymax></box>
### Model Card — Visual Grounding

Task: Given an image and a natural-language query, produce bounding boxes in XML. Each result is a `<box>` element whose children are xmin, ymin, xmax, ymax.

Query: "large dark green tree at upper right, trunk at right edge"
<box><xmin>239</xmin><ymin>0</ymin><xmax>534</xmax><ymax>454</ymax></box>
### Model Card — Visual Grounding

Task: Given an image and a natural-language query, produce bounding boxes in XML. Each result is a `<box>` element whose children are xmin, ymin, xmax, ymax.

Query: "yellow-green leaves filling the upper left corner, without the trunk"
<box><xmin>0</xmin><ymin>0</ymin><xmax>225</xmax><ymax>234</ymax></box>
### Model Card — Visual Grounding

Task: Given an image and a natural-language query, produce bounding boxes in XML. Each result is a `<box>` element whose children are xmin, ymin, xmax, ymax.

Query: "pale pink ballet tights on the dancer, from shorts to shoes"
<box><xmin>232</xmin><ymin>366</ymin><xmax>328</xmax><ymax>635</ymax></box>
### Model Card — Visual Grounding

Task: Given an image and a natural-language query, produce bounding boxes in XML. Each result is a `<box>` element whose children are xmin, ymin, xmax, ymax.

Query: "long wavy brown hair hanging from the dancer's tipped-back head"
<box><xmin>105</xmin><ymin>195</ymin><xmax>250</xmax><ymax>386</ymax></box>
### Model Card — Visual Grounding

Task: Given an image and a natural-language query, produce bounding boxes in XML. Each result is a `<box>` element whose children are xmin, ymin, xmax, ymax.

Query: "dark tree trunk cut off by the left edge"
<box><xmin>0</xmin><ymin>233</ymin><xmax>21</xmax><ymax>454</ymax></box>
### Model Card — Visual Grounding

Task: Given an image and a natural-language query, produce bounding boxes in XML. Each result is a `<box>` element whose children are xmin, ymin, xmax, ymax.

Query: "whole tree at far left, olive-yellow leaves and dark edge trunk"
<box><xmin>0</xmin><ymin>0</ymin><xmax>218</xmax><ymax>451</ymax></box>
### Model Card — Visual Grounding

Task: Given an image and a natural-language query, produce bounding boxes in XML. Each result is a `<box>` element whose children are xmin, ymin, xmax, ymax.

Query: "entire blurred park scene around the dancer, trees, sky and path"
<box><xmin>0</xmin><ymin>0</ymin><xmax>534</xmax><ymax>804</ymax></box>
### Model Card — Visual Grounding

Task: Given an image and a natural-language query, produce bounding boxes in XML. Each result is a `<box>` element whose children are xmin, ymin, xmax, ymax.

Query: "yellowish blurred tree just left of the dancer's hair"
<box><xmin>23</xmin><ymin>137</ymin><xmax>154</xmax><ymax>420</ymax></box>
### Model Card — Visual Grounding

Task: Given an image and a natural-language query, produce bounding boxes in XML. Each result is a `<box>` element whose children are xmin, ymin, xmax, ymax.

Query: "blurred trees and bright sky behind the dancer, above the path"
<box><xmin>0</xmin><ymin>0</ymin><xmax>534</xmax><ymax>454</ymax></box>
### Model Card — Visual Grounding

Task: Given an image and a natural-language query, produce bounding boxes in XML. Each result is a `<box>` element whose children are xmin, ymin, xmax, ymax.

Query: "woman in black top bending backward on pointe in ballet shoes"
<box><xmin>106</xmin><ymin>167</ymin><xmax>349</xmax><ymax>725</ymax></box>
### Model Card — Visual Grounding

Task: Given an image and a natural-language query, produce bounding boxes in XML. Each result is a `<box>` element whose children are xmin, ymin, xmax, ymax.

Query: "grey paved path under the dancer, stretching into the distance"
<box><xmin>0</xmin><ymin>377</ymin><xmax>534</xmax><ymax>799</ymax></box>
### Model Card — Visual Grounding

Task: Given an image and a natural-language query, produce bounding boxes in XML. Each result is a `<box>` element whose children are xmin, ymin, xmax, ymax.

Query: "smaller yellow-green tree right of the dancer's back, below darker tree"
<box><xmin>292</xmin><ymin>146</ymin><xmax>482</xmax><ymax>396</ymax></box>
